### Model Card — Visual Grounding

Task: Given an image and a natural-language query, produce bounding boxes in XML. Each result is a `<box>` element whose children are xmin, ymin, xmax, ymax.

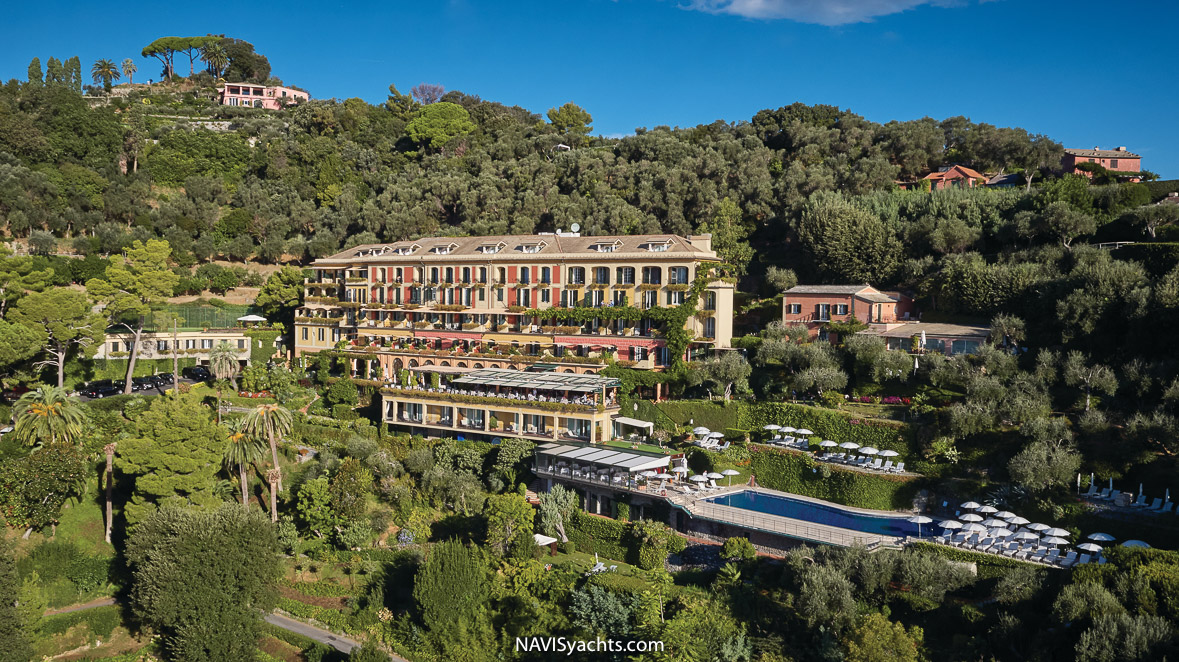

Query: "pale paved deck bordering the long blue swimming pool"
<box><xmin>667</xmin><ymin>485</ymin><xmax>903</xmax><ymax>549</ymax></box>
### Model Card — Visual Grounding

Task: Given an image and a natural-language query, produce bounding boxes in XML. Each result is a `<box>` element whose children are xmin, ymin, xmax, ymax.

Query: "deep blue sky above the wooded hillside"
<box><xmin>0</xmin><ymin>0</ymin><xmax>1179</xmax><ymax>178</ymax></box>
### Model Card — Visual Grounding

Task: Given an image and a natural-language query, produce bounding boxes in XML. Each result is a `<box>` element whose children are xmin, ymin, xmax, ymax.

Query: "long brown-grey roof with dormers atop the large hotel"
<box><xmin>312</xmin><ymin>232</ymin><xmax>717</xmax><ymax>266</ymax></box>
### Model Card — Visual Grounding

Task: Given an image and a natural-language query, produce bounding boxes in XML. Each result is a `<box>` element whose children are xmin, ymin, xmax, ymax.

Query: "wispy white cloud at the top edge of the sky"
<box><xmin>681</xmin><ymin>0</ymin><xmax>962</xmax><ymax>26</ymax></box>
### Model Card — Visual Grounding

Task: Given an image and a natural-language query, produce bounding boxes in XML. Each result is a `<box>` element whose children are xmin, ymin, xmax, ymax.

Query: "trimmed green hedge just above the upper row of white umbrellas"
<box><xmin>731</xmin><ymin>402</ymin><xmax>917</xmax><ymax>459</ymax></box>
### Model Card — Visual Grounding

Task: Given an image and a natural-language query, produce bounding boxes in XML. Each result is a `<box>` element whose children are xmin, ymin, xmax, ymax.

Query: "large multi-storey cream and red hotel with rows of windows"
<box><xmin>295</xmin><ymin>232</ymin><xmax>733</xmax><ymax>439</ymax></box>
